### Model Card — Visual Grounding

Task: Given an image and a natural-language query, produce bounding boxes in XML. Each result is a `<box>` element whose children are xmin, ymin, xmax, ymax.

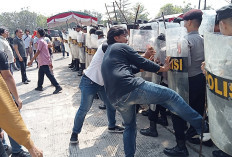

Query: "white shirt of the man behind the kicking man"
<box><xmin>84</xmin><ymin>45</ymin><xmax>105</xmax><ymax>86</ymax></box>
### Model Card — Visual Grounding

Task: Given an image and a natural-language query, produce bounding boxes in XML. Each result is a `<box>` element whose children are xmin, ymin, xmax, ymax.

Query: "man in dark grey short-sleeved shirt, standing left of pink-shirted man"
<box><xmin>13</xmin><ymin>29</ymin><xmax>30</xmax><ymax>84</ymax></box>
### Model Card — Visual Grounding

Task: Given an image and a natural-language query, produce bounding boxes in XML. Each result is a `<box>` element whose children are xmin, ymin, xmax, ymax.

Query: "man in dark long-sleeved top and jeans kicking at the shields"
<box><xmin>102</xmin><ymin>27</ymin><xmax>207</xmax><ymax>157</ymax></box>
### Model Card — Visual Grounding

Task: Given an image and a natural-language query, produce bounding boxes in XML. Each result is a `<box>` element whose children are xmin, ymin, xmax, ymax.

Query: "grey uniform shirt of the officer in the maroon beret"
<box><xmin>185</xmin><ymin>31</ymin><xmax>205</xmax><ymax>77</ymax></box>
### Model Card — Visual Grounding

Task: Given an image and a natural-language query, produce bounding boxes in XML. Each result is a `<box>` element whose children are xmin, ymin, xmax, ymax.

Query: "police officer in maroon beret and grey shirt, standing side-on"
<box><xmin>164</xmin><ymin>9</ymin><xmax>206</xmax><ymax>156</ymax></box>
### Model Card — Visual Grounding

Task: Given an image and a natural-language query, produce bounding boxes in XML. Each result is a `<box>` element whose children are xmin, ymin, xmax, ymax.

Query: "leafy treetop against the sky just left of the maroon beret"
<box><xmin>157</xmin><ymin>3</ymin><xmax>182</xmax><ymax>17</ymax></box>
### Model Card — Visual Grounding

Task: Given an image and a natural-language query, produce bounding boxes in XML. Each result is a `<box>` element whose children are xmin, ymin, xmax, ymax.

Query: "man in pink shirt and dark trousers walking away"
<box><xmin>28</xmin><ymin>28</ymin><xmax>62</xmax><ymax>94</ymax></box>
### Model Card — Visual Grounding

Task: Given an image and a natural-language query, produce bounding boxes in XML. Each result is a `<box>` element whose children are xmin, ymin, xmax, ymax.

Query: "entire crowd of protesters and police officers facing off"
<box><xmin>0</xmin><ymin>2</ymin><xmax>232</xmax><ymax>157</ymax></box>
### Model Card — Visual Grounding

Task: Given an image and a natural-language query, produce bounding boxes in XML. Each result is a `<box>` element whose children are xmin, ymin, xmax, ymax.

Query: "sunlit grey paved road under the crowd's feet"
<box><xmin>9</xmin><ymin>54</ymin><xmax>215</xmax><ymax>157</ymax></box>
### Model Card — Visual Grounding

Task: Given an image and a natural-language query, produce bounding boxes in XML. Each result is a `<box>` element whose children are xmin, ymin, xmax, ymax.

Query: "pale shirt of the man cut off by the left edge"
<box><xmin>0</xmin><ymin>35</ymin><xmax>14</xmax><ymax>63</ymax></box>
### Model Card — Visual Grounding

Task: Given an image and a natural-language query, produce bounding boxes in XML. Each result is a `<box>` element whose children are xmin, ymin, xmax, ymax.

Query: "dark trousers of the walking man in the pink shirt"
<box><xmin>38</xmin><ymin>65</ymin><xmax>60</xmax><ymax>88</ymax></box>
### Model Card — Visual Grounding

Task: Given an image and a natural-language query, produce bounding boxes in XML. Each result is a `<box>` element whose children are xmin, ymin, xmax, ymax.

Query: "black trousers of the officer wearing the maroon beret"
<box><xmin>172</xmin><ymin>74</ymin><xmax>206</xmax><ymax>140</ymax></box>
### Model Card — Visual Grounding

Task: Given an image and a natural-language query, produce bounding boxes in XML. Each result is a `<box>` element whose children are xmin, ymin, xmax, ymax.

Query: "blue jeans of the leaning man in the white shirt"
<box><xmin>73</xmin><ymin>75</ymin><xmax>116</xmax><ymax>134</ymax></box>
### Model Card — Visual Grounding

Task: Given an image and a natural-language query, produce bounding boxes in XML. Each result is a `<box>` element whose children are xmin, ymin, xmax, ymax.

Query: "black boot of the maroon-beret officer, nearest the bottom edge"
<box><xmin>164</xmin><ymin>140</ymin><xmax>189</xmax><ymax>157</ymax></box>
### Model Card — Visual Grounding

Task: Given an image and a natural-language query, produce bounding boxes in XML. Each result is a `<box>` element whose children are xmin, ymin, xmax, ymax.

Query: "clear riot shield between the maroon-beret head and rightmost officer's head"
<box><xmin>199</xmin><ymin>10</ymin><xmax>216</xmax><ymax>35</ymax></box>
